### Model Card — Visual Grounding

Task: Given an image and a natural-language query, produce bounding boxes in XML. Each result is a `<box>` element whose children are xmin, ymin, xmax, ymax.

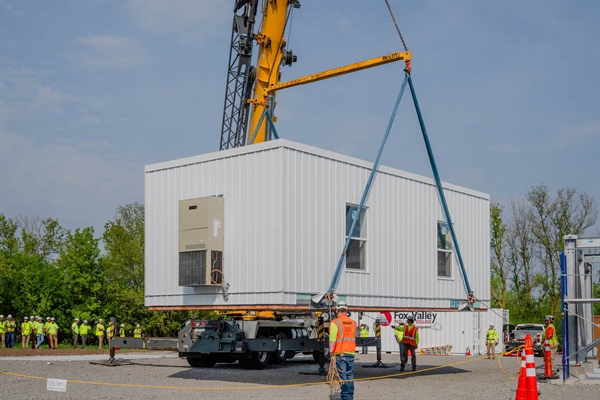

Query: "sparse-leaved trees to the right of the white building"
<box><xmin>490</xmin><ymin>185</ymin><xmax>600</xmax><ymax>332</ymax></box>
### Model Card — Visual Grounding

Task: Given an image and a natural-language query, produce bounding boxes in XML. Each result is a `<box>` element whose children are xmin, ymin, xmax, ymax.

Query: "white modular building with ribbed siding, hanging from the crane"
<box><xmin>145</xmin><ymin>139</ymin><xmax>490</xmax><ymax>312</ymax></box>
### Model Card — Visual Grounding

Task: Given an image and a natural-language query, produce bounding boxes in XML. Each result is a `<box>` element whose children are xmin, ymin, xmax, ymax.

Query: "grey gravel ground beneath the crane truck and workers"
<box><xmin>0</xmin><ymin>350</ymin><xmax>600</xmax><ymax>400</ymax></box>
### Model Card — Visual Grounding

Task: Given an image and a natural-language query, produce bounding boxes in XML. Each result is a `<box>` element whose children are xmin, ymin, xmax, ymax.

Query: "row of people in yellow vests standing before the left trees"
<box><xmin>0</xmin><ymin>314</ymin><xmax>142</xmax><ymax>349</ymax></box>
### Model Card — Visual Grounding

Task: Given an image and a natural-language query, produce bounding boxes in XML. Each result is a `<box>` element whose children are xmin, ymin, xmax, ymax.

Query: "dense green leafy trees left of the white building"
<box><xmin>0</xmin><ymin>203</ymin><xmax>211</xmax><ymax>344</ymax></box>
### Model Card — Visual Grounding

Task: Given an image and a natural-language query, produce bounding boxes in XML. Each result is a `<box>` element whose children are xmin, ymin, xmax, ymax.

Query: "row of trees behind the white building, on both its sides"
<box><xmin>0</xmin><ymin>185</ymin><xmax>600</xmax><ymax>337</ymax></box>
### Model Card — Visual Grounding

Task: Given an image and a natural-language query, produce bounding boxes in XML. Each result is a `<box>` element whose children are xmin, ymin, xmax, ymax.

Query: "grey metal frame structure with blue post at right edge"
<box><xmin>561</xmin><ymin>235</ymin><xmax>600</xmax><ymax>379</ymax></box>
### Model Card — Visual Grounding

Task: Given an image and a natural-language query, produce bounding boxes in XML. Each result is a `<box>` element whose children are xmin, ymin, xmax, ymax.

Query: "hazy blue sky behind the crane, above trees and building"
<box><xmin>0</xmin><ymin>0</ymin><xmax>600</xmax><ymax>236</ymax></box>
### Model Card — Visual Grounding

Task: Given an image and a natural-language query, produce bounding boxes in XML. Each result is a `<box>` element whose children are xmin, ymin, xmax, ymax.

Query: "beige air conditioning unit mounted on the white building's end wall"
<box><xmin>178</xmin><ymin>196</ymin><xmax>224</xmax><ymax>286</ymax></box>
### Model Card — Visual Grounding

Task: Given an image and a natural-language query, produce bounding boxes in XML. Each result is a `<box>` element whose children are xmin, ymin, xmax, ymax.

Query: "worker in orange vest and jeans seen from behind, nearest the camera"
<box><xmin>329</xmin><ymin>301</ymin><xmax>356</xmax><ymax>400</ymax></box>
